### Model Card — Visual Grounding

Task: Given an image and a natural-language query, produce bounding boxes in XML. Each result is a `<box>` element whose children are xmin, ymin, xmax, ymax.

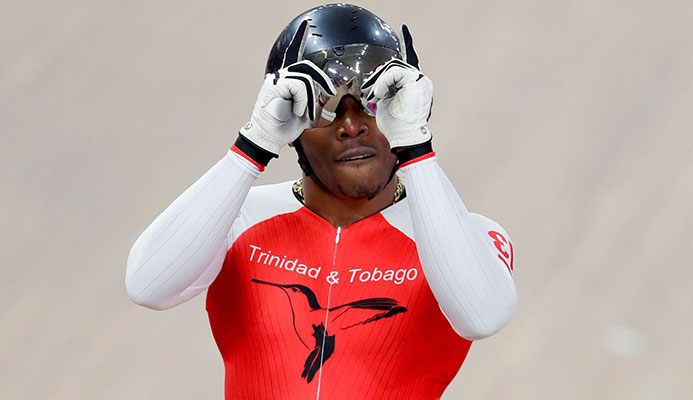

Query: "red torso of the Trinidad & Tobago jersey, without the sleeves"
<box><xmin>207</xmin><ymin>184</ymin><xmax>491</xmax><ymax>399</ymax></box>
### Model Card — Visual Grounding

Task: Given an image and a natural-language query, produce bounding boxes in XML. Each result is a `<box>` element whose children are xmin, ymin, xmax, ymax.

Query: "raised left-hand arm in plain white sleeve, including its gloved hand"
<box><xmin>125</xmin><ymin>21</ymin><xmax>335</xmax><ymax>310</ymax></box>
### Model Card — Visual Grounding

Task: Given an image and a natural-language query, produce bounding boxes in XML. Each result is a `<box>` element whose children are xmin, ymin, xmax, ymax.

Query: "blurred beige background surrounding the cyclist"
<box><xmin>0</xmin><ymin>0</ymin><xmax>693</xmax><ymax>399</ymax></box>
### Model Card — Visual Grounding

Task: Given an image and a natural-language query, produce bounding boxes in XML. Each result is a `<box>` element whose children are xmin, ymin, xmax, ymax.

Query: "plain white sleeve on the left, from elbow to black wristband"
<box><xmin>125</xmin><ymin>150</ymin><xmax>260</xmax><ymax>310</ymax></box>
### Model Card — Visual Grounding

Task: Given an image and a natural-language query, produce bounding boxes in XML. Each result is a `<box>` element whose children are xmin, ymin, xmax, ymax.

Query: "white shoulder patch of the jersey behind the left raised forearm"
<box><xmin>228</xmin><ymin>181</ymin><xmax>303</xmax><ymax>246</ymax></box>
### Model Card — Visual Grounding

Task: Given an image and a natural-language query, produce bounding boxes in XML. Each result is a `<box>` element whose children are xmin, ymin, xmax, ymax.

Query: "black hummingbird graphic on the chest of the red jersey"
<box><xmin>251</xmin><ymin>279</ymin><xmax>407</xmax><ymax>383</ymax></box>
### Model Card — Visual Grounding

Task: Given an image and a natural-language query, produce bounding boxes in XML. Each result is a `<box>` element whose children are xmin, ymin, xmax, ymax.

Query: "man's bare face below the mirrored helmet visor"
<box><xmin>299</xmin><ymin>96</ymin><xmax>397</xmax><ymax>199</ymax></box>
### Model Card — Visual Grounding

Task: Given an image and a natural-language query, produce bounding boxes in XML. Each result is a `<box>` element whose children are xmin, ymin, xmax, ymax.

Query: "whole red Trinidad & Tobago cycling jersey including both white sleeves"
<box><xmin>126</xmin><ymin>151</ymin><xmax>517</xmax><ymax>399</ymax></box>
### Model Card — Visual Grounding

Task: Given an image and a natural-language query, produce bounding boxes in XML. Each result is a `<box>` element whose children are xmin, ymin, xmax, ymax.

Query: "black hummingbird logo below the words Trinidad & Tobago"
<box><xmin>251</xmin><ymin>279</ymin><xmax>407</xmax><ymax>383</ymax></box>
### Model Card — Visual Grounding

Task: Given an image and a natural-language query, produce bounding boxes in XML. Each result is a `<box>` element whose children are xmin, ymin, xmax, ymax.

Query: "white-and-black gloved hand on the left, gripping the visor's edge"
<box><xmin>239</xmin><ymin>21</ymin><xmax>337</xmax><ymax>157</ymax></box>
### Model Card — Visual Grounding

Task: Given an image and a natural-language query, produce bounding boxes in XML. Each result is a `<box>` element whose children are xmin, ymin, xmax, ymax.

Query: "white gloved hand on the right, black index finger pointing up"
<box><xmin>361</xmin><ymin>25</ymin><xmax>433</xmax><ymax>149</ymax></box>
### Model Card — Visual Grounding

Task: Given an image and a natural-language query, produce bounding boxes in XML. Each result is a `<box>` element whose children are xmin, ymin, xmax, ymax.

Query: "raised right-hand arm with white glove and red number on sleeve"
<box><xmin>362</xmin><ymin>26</ymin><xmax>517</xmax><ymax>340</ymax></box>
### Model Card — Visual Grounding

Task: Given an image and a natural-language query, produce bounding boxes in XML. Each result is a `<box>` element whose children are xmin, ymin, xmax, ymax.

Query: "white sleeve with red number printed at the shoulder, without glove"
<box><xmin>401</xmin><ymin>157</ymin><xmax>517</xmax><ymax>340</ymax></box>
